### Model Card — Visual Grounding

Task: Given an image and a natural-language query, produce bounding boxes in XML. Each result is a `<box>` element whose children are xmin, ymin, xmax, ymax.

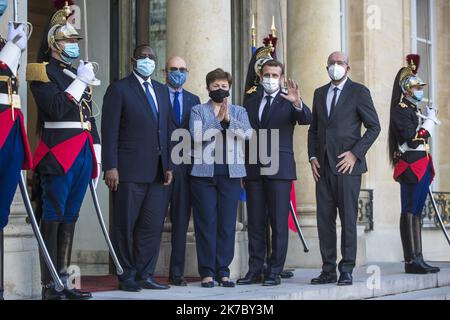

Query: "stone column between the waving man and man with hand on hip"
<box><xmin>286</xmin><ymin>0</ymin><xmax>370</xmax><ymax>267</ymax></box>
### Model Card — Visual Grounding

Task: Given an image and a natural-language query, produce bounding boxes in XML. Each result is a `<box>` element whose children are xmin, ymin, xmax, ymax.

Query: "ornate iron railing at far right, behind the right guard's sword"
<box><xmin>422</xmin><ymin>192</ymin><xmax>450</xmax><ymax>228</ymax></box>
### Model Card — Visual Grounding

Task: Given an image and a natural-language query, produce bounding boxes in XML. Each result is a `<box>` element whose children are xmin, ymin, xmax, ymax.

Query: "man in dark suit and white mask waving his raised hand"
<box><xmin>238</xmin><ymin>60</ymin><xmax>311</xmax><ymax>286</ymax></box>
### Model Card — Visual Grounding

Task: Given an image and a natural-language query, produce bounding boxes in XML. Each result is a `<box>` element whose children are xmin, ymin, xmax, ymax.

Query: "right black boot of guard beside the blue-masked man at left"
<box><xmin>56</xmin><ymin>223</ymin><xmax>92</xmax><ymax>300</ymax></box>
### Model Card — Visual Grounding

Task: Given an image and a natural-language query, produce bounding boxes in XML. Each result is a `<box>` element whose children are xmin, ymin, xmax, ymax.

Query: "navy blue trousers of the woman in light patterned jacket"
<box><xmin>191</xmin><ymin>176</ymin><xmax>241</xmax><ymax>278</ymax></box>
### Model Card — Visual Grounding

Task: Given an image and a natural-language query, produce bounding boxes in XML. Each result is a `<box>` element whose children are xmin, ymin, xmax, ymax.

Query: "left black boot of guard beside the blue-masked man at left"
<box><xmin>39</xmin><ymin>221</ymin><xmax>64</xmax><ymax>300</ymax></box>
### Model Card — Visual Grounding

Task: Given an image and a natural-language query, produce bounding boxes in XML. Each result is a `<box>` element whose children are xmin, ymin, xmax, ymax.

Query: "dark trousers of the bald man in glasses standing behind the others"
<box><xmin>169</xmin><ymin>165</ymin><xmax>191</xmax><ymax>278</ymax></box>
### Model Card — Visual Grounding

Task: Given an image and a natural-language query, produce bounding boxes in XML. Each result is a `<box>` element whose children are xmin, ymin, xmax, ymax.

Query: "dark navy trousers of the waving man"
<box><xmin>245</xmin><ymin>178</ymin><xmax>292</xmax><ymax>275</ymax></box>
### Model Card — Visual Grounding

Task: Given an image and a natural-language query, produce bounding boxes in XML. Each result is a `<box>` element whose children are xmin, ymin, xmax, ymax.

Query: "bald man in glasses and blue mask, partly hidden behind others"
<box><xmin>165</xmin><ymin>57</ymin><xmax>200</xmax><ymax>286</ymax></box>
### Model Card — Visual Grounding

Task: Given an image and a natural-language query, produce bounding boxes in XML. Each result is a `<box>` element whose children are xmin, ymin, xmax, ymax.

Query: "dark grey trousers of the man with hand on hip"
<box><xmin>316</xmin><ymin>159</ymin><xmax>361</xmax><ymax>273</ymax></box>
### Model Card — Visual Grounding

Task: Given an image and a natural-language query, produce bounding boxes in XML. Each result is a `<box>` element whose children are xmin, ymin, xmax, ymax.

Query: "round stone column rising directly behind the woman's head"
<box><xmin>167</xmin><ymin>0</ymin><xmax>232</xmax><ymax>102</ymax></box>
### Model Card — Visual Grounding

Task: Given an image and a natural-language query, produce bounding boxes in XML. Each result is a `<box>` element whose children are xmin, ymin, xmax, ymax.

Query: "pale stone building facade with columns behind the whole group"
<box><xmin>0</xmin><ymin>0</ymin><xmax>450</xmax><ymax>298</ymax></box>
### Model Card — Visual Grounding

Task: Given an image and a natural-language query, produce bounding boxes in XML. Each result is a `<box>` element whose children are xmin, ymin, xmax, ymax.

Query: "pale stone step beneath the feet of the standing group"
<box><xmin>94</xmin><ymin>263</ymin><xmax>450</xmax><ymax>300</ymax></box>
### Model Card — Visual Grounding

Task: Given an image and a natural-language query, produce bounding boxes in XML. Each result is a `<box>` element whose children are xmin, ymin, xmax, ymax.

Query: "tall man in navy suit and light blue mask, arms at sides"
<box><xmin>102</xmin><ymin>45</ymin><xmax>172</xmax><ymax>292</ymax></box>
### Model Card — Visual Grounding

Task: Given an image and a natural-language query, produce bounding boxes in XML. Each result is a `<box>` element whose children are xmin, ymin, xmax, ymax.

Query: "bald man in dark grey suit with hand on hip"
<box><xmin>308</xmin><ymin>52</ymin><xmax>381</xmax><ymax>285</ymax></box>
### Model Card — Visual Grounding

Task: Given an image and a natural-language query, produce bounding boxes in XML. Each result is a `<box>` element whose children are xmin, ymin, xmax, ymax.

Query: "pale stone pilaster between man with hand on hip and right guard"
<box><xmin>349</xmin><ymin>0</ymin><xmax>411</xmax><ymax>261</ymax></box>
